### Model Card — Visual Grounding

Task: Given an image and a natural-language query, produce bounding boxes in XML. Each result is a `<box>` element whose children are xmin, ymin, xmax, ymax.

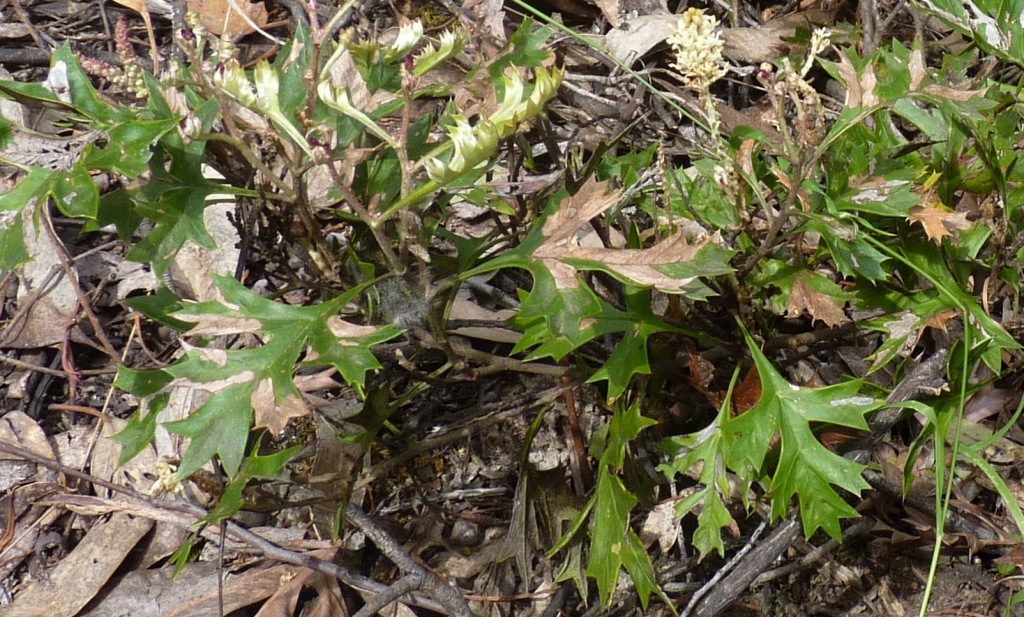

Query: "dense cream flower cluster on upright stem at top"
<box><xmin>668</xmin><ymin>8</ymin><xmax>726</xmax><ymax>90</ymax></box>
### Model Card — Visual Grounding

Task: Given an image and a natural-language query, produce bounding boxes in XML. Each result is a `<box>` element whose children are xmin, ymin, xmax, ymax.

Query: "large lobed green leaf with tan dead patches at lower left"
<box><xmin>118</xmin><ymin>276</ymin><xmax>400</xmax><ymax>477</ymax></box>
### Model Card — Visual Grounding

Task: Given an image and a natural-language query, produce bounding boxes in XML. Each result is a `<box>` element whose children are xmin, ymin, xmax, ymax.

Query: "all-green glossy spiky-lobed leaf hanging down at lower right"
<box><xmin>723</xmin><ymin>335</ymin><xmax>878</xmax><ymax>538</ymax></box>
